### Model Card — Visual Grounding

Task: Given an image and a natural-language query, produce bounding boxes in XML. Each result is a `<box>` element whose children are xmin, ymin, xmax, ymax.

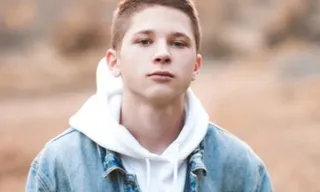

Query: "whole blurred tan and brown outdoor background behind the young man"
<box><xmin>0</xmin><ymin>0</ymin><xmax>320</xmax><ymax>192</ymax></box>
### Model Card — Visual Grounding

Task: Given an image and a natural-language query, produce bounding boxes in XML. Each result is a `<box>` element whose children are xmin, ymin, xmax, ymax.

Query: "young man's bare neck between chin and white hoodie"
<box><xmin>120</xmin><ymin>93</ymin><xmax>185</xmax><ymax>154</ymax></box>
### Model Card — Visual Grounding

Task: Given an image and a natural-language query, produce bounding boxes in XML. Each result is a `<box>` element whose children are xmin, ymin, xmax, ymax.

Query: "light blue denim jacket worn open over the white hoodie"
<box><xmin>26</xmin><ymin>124</ymin><xmax>273</xmax><ymax>192</ymax></box>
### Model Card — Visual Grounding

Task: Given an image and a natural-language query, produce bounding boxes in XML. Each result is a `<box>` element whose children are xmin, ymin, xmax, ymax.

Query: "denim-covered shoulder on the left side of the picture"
<box><xmin>26</xmin><ymin>128</ymin><xmax>101</xmax><ymax>191</ymax></box>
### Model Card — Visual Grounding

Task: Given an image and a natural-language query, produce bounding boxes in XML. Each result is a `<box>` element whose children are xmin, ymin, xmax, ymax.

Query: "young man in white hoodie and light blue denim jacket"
<box><xmin>26</xmin><ymin>0</ymin><xmax>272</xmax><ymax>192</ymax></box>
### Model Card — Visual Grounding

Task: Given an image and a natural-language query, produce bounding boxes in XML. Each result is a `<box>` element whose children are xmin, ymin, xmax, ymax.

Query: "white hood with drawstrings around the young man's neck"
<box><xmin>69</xmin><ymin>58</ymin><xmax>209</xmax><ymax>189</ymax></box>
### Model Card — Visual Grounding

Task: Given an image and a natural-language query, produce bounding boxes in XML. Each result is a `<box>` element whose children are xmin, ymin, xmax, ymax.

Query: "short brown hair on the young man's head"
<box><xmin>111</xmin><ymin>0</ymin><xmax>201</xmax><ymax>51</ymax></box>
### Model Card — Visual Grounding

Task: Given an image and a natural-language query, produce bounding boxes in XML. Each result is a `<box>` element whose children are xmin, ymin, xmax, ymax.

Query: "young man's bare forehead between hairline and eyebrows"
<box><xmin>127</xmin><ymin>6</ymin><xmax>193</xmax><ymax>39</ymax></box>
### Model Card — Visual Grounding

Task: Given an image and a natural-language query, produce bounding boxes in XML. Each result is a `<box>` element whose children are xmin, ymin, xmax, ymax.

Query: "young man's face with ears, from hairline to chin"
<box><xmin>106</xmin><ymin>6</ymin><xmax>201</xmax><ymax>102</ymax></box>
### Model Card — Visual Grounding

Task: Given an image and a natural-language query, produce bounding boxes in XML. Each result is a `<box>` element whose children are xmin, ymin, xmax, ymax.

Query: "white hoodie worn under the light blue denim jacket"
<box><xmin>69</xmin><ymin>58</ymin><xmax>209</xmax><ymax>192</ymax></box>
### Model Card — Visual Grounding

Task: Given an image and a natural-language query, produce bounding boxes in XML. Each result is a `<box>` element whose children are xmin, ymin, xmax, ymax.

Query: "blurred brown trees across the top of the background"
<box><xmin>0</xmin><ymin>0</ymin><xmax>320</xmax><ymax>58</ymax></box>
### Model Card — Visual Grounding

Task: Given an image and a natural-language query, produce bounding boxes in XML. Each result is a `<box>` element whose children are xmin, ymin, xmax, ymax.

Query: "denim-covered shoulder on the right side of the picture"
<box><xmin>203</xmin><ymin>123</ymin><xmax>272</xmax><ymax>191</ymax></box>
